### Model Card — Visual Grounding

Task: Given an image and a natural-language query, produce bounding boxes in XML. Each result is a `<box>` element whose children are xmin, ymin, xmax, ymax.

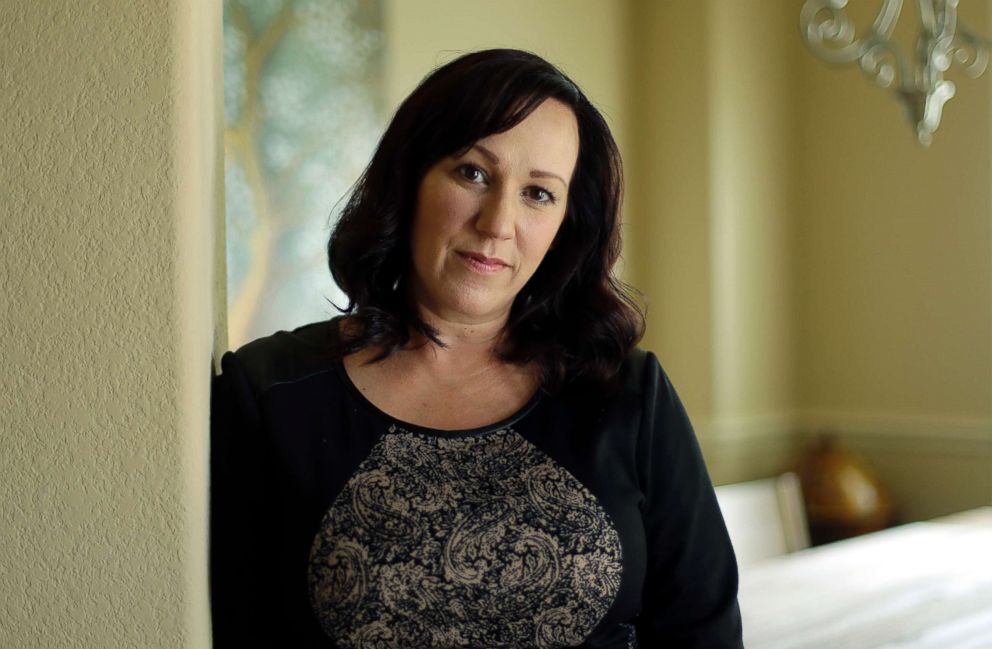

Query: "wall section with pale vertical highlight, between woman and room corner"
<box><xmin>629</xmin><ymin>0</ymin><xmax>798</xmax><ymax>481</ymax></box>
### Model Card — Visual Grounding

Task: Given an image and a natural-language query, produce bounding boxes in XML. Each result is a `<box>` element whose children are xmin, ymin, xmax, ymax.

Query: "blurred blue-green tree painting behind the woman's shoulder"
<box><xmin>224</xmin><ymin>0</ymin><xmax>384</xmax><ymax>348</ymax></box>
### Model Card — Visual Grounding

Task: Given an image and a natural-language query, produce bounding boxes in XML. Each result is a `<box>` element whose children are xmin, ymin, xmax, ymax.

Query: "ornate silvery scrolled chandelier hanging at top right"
<box><xmin>799</xmin><ymin>0</ymin><xmax>989</xmax><ymax>146</ymax></box>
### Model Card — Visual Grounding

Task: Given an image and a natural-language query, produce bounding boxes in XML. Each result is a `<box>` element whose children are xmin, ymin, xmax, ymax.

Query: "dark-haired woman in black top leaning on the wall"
<box><xmin>211</xmin><ymin>50</ymin><xmax>741</xmax><ymax>649</ymax></box>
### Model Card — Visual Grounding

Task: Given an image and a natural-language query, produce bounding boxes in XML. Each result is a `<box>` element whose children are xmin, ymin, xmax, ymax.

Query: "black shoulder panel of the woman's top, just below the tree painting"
<box><xmin>222</xmin><ymin>318</ymin><xmax>338</xmax><ymax>394</ymax></box>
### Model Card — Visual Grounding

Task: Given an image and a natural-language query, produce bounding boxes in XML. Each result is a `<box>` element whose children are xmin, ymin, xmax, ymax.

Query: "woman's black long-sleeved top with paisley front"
<box><xmin>211</xmin><ymin>321</ymin><xmax>742</xmax><ymax>649</ymax></box>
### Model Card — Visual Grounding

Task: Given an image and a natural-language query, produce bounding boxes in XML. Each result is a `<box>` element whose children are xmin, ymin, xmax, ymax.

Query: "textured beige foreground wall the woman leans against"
<box><xmin>0</xmin><ymin>0</ymin><xmax>217</xmax><ymax>649</ymax></box>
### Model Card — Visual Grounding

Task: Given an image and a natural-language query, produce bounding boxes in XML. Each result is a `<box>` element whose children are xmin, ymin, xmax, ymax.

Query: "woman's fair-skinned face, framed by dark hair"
<box><xmin>411</xmin><ymin>99</ymin><xmax>579</xmax><ymax>324</ymax></box>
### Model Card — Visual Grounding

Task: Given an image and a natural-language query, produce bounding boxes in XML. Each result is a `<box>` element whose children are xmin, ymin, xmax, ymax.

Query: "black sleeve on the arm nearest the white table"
<box><xmin>637</xmin><ymin>354</ymin><xmax>743</xmax><ymax>649</ymax></box>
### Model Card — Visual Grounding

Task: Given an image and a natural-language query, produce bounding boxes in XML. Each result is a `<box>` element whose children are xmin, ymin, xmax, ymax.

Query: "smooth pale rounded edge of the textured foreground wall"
<box><xmin>177</xmin><ymin>0</ymin><xmax>227</xmax><ymax>647</ymax></box>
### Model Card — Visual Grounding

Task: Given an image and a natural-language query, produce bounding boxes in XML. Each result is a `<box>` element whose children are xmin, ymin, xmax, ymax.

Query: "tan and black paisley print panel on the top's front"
<box><xmin>308</xmin><ymin>427</ymin><xmax>621</xmax><ymax>649</ymax></box>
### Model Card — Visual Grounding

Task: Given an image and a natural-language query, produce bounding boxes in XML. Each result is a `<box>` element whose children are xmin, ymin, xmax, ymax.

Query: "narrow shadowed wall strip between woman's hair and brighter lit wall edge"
<box><xmin>626</xmin><ymin>0</ymin><xmax>716</xmax><ymax>418</ymax></box>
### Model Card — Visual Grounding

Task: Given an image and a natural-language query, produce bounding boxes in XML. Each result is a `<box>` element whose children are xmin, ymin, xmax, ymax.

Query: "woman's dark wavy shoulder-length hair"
<box><xmin>327</xmin><ymin>49</ymin><xmax>644</xmax><ymax>390</ymax></box>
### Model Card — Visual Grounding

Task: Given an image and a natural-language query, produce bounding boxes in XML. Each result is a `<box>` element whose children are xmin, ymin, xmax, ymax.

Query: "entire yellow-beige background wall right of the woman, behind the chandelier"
<box><xmin>629</xmin><ymin>0</ymin><xmax>992</xmax><ymax>506</ymax></box>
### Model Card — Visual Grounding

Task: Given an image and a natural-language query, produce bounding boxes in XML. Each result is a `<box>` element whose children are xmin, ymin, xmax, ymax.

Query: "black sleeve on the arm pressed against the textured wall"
<box><xmin>210</xmin><ymin>352</ymin><xmax>275</xmax><ymax>649</ymax></box>
